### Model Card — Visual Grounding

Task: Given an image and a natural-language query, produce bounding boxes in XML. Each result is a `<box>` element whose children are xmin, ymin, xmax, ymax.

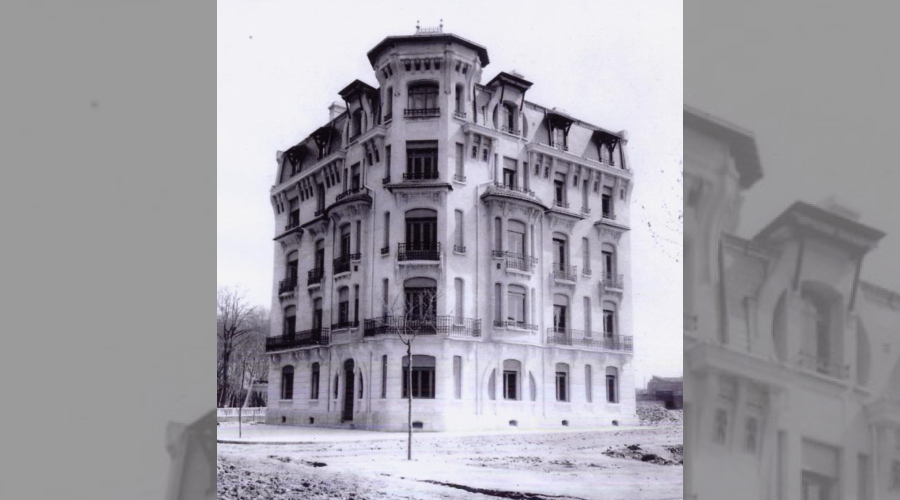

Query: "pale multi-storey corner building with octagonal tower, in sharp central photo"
<box><xmin>267</xmin><ymin>29</ymin><xmax>635</xmax><ymax>430</ymax></box>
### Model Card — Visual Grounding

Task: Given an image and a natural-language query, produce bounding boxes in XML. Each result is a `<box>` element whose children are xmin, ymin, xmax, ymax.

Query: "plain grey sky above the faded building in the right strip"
<box><xmin>684</xmin><ymin>0</ymin><xmax>900</xmax><ymax>290</ymax></box>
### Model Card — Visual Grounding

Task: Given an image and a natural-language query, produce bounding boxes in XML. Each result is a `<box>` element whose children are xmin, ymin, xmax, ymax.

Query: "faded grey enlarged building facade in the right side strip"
<box><xmin>684</xmin><ymin>109</ymin><xmax>900</xmax><ymax>500</ymax></box>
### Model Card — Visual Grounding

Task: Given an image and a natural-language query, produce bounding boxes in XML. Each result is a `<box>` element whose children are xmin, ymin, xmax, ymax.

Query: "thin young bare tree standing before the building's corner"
<box><xmin>391</xmin><ymin>289</ymin><xmax>443</xmax><ymax>460</ymax></box>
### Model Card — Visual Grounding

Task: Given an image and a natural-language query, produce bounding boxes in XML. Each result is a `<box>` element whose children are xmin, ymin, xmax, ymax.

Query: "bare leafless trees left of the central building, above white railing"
<box><xmin>216</xmin><ymin>287</ymin><xmax>261</xmax><ymax>407</ymax></box>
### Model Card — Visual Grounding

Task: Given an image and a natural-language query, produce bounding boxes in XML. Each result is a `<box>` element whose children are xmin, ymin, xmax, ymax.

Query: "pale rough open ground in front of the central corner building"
<box><xmin>218</xmin><ymin>425</ymin><xmax>683</xmax><ymax>500</ymax></box>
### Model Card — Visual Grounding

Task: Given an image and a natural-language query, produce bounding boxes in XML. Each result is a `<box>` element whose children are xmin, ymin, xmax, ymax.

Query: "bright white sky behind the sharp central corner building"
<box><xmin>216</xmin><ymin>0</ymin><xmax>683</xmax><ymax>385</ymax></box>
